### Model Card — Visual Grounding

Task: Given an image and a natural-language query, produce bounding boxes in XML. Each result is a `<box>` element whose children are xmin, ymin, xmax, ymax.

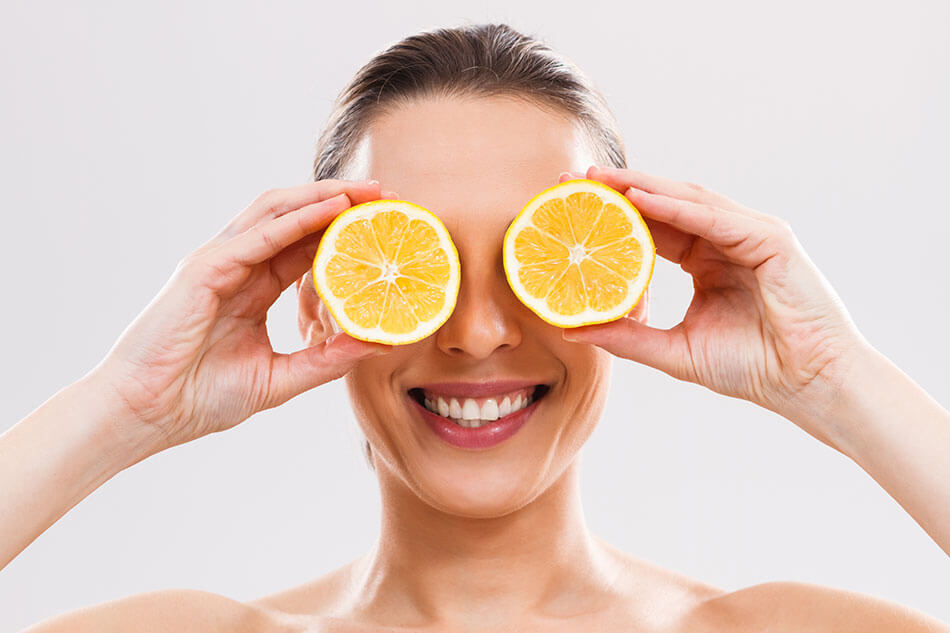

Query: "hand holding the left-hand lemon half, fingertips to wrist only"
<box><xmin>92</xmin><ymin>180</ymin><xmax>391</xmax><ymax>452</ymax></box>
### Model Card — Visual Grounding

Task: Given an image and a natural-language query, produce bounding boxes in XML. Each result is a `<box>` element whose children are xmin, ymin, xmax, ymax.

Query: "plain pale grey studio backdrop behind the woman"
<box><xmin>0</xmin><ymin>0</ymin><xmax>950</xmax><ymax>631</ymax></box>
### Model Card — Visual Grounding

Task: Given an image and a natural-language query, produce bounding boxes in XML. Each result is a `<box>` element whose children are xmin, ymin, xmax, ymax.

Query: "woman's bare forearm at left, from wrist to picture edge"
<box><xmin>0</xmin><ymin>374</ymin><xmax>160</xmax><ymax>569</ymax></box>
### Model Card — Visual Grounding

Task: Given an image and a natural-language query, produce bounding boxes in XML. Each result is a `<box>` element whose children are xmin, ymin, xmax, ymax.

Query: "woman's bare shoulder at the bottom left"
<box><xmin>23</xmin><ymin>589</ymin><xmax>286</xmax><ymax>633</ymax></box>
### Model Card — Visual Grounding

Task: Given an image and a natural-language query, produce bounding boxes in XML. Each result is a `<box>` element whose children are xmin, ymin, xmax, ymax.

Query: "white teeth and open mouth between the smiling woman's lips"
<box><xmin>408</xmin><ymin>384</ymin><xmax>550</xmax><ymax>428</ymax></box>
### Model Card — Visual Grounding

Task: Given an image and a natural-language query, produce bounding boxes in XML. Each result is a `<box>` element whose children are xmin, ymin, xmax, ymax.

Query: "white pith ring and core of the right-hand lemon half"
<box><xmin>503</xmin><ymin>180</ymin><xmax>656</xmax><ymax>327</ymax></box>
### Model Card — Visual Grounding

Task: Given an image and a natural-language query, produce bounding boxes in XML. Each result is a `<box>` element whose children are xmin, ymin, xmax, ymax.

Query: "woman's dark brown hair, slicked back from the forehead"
<box><xmin>313</xmin><ymin>24</ymin><xmax>627</xmax><ymax>468</ymax></box>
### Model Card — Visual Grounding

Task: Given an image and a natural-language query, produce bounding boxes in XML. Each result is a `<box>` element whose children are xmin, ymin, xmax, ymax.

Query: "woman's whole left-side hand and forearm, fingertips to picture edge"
<box><xmin>0</xmin><ymin>180</ymin><xmax>388</xmax><ymax>569</ymax></box>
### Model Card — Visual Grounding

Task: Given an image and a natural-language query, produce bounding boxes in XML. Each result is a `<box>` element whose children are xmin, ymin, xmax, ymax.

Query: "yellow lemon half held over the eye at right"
<box><xmin>504</xmin><ymin>179</ymin><xmax>656</xmax><ymax>327</ymax></box>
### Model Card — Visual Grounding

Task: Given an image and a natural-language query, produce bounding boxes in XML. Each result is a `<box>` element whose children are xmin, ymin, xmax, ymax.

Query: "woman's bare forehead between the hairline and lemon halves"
<box><xmin>346</xmin><ymin>96</ymin><xmax>593</xmax><ymax>230</ymax></box>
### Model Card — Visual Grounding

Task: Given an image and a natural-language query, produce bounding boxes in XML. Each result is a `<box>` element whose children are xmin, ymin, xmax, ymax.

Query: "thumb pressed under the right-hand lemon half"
<box><xmin>561</xmin><ymin>317</ymin><xmax>689</xmax><ymax>380</ymax></box>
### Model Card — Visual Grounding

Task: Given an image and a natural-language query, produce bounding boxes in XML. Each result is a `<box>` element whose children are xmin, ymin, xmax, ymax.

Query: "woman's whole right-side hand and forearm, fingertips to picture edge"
<box><xmin>561</xmin><ymin>166</ymin><xmax>950</xmax><ymax>554</ymax></box>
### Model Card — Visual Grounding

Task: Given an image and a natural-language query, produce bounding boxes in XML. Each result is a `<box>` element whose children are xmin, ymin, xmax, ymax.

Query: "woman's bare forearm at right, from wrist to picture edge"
<box><xmin>796</xmin><ymin>347</ymin><xmax>950</xmax><ymax>554</ymax></box>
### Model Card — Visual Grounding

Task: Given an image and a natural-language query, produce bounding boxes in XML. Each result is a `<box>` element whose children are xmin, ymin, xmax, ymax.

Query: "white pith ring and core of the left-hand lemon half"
<box><xmin>312</xmin><ymin>200</ymin><xmax>461</xmax><ymax>345</ymax></box>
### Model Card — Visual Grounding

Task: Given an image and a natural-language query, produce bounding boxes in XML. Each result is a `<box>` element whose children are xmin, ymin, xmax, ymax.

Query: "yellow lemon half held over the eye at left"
<box><xmin>313</xmin><ymin>200</ymin><xmax>460</xmax><ymax>345</ymax></box>
